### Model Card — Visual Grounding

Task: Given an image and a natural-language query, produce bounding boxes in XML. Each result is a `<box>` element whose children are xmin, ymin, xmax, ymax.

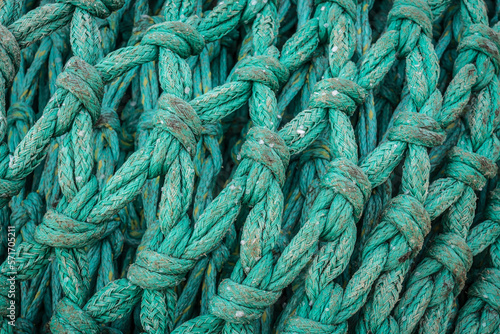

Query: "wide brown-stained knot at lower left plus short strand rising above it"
<box><xmin>34</xmin><ymin>177</ymin><xmax>103</xmax><ymax>248</ymax></box>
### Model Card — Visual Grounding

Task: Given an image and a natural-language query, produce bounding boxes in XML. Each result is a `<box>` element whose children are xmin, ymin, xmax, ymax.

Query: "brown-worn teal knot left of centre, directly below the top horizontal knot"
<box><xmin>154</xmin><ymin>93</ymin><xmax>202</xmax><ymax>156</ymax></box>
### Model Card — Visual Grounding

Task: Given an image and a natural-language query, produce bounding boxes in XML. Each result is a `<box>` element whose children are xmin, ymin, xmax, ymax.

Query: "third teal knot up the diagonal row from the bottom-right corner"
<box><xmin>381</xmin><ymin>195</ymin><xmax>431</xmax><ymax>257</ymax></box>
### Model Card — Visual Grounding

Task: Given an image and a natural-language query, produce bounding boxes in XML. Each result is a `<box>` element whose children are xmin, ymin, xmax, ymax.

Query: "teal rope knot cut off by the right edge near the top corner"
<box><xmin>457</xmin><ymin>24</ymin><xmax>500</xmax><ymax>75</ymax></box>
